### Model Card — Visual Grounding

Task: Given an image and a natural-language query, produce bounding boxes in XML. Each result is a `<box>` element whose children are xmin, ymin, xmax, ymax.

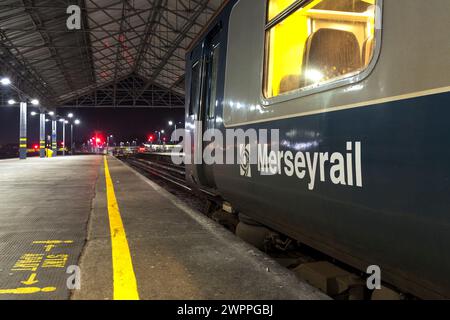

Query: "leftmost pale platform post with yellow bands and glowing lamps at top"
<box><xmin>0</xmin><ymin>77</ymin><xmax>39</xmax><ymax>160</ymax></box>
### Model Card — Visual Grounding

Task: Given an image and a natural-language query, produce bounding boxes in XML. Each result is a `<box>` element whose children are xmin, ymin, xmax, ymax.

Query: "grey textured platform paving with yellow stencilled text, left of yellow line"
<box><xmin>0</xmin><ymin>156</ymin><xmax>102</xmax><ymax>299</ymax></box>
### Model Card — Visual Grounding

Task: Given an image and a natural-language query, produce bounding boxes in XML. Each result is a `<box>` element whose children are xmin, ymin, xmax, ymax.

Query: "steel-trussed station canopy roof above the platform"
<box><xmin>0</xmin><ymin>0</ymin><xmax>224</xmax><ymax>108</ymax></box>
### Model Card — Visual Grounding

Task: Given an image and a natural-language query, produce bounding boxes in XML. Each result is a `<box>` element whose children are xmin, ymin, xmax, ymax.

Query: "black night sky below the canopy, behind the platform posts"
<box><xmin>0</xmin><ymin>106</ymin><xmax>184</xmax><ymax>146</ymax></box>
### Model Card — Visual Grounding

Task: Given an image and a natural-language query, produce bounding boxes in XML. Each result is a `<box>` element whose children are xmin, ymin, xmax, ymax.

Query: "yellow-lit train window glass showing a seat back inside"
<box><xmin>264</xmin><ymin>0</ymin><xmax>376</xmax><ymax>98</ymax></box>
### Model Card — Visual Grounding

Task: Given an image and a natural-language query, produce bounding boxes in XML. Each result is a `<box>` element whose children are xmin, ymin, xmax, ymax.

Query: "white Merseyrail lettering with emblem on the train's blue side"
<box><xmin>240</xmin><ymin>142</ymin><xmax>363</xmax><ymax>191</ymax></box>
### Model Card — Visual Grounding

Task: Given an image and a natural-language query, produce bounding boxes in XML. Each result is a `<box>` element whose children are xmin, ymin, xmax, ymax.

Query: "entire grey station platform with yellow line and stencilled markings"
<box><xmin>0</xmin><ymin>156</ymin><xmax>328</xmax><ymax>300</ymax></box>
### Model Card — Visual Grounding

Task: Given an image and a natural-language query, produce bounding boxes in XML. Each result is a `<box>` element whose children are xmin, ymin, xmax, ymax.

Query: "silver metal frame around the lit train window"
<box><xmin>260</xmin><ymin>0</ymin><xmax>384</xmax><ymax>109</ymax></box>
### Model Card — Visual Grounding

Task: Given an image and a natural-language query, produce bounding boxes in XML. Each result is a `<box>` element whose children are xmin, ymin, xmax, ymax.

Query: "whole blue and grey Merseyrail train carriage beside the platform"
<box><xmin>185</xmin><ymin>0</ymin><xmax>450</xmax><ymax>299</ymax></box>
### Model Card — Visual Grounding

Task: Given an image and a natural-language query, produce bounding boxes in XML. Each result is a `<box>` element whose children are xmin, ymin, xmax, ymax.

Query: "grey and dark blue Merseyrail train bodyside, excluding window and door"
<box><xmin>186</xmin><ymin>0</ymin><xmax>450</xmax><ymax>298</ymax></box>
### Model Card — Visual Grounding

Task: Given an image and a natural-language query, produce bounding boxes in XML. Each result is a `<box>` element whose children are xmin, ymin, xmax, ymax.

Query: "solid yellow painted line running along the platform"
<box><xmin>104</xmin><ymin>156</ymin><xmax>139</xmax><ymax>300</ymax></box>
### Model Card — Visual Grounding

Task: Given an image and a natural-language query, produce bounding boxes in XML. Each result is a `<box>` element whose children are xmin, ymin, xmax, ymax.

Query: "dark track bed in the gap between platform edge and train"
<box><xmin>118</xmin><ymin>154</ymin><xmax>414</xmax><ymax>300</ymax></box>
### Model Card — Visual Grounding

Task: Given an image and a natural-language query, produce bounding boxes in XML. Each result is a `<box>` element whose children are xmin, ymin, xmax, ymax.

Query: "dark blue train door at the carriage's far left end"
<box><xmin>191</xmin><ymin>24</ymin><xmax>221</xmax><ymax>188</ymax></box>
